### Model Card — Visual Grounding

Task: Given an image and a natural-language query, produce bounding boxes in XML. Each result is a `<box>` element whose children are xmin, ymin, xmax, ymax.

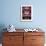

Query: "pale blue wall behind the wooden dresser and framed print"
<box><xmin>0</xmin><ymin>0</ymin><xmax>46</xmax><ymax>30</ymax></box>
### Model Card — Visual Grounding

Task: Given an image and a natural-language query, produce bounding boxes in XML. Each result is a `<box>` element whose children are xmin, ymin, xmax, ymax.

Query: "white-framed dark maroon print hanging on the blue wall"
<box><xmin>21</xmin><ymin>5</ymin><xmax>32</xmax><ymax>21</ymax></box>
